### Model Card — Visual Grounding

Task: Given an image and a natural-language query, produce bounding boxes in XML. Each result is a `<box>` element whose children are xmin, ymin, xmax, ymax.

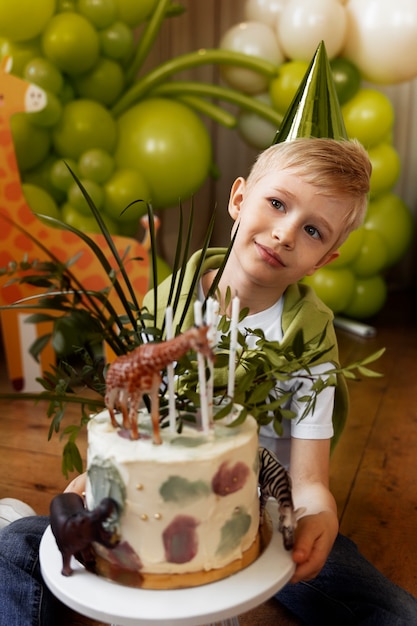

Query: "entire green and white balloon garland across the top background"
<box><xmin>0</xmin><ymin>0</ymin><xmax>417</xmax><ymax>317</ymax></box>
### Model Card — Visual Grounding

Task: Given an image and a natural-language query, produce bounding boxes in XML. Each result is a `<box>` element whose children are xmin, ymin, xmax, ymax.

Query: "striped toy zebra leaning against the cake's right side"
<box><xmin>258</xmin><ymin>447</ymin><xmax>297</xmax><ymax>550</ymax></box>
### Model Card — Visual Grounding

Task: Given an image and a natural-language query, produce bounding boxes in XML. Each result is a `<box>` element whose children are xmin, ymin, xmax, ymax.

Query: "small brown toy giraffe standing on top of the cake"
<box><xmin>104</xmin><ymin>326</ymin><xmax>214</xmax><ymax>445</ymax></box>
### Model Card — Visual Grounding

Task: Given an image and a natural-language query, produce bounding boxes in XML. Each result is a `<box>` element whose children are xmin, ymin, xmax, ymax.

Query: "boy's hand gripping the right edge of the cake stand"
<box><xmin>291</xmin><ymin>511</ymin><xmax>339</xmax><ymax>583</ymax></box>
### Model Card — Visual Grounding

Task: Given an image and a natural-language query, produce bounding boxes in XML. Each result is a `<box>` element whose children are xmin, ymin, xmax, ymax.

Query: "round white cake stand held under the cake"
<box><xmin>40</xmin><ymin>501</ymin><xmax>295</xmax><ymax>626</ymax></box>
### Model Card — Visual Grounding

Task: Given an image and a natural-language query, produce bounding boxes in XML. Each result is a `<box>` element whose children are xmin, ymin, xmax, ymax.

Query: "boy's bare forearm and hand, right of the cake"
<box><xmin>290</xmin><ymin>438</ymin><xmax>339</xmax><ymax>582</ymax></box>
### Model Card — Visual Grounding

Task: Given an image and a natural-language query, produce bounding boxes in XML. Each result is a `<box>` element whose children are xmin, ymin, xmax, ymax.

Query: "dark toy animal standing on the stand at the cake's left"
<box><xmin>50</xmin><ymin>493</ymin><xmax>119</xmax><ymax>576</ymax></box>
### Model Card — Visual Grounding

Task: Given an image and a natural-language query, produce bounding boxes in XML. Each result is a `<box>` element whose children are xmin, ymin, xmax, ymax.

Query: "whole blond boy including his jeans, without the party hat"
<box><xmin>0</xmin><ymin>139</ymin><xmax>417</xmax><ymax>626</ymax></box>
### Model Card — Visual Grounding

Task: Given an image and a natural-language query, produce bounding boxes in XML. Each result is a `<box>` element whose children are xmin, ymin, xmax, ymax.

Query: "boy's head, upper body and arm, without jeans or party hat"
<box><xmin>144</xmin><ymin>139</ymin><xmax>371</xmax><ymax>582</ymax></box>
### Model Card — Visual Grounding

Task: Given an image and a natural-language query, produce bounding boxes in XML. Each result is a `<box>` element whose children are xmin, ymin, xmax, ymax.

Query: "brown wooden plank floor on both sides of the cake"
<box><xmin>0</xmin><ymin>292</ymin><xmax>417</xmax><ymax>626</ymax></box>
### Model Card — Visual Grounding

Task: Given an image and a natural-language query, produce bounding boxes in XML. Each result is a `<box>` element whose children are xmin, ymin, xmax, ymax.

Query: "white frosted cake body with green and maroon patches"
<box><xmin>87</xmin><ymin>411</ymin><xmax>259</xmax><ymax>573</ymax></box>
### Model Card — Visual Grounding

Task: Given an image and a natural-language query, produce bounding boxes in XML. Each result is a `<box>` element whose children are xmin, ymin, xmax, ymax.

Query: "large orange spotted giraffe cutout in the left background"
<box><xmin>0</xmin><ymin>57</ymin><xmax>149</xmax><ymax>391</ymax></box>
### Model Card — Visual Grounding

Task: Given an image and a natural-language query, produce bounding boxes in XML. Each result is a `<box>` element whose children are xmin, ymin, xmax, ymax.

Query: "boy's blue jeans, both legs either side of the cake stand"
<box><xmin>0</xmin><ymin>517</ymin><xmax>417</xmax><ymax>626</ymax></box>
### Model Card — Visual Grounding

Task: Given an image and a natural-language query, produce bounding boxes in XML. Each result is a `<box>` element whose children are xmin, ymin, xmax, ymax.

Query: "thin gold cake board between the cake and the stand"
<box><xmin>88</xmin><ymin>513</ymin><xmax>272</xmax><ymax>590</ymax></box>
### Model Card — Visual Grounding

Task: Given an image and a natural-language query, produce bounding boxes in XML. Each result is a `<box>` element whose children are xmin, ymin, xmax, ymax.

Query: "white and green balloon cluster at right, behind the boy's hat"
<box><xmin>220</xmin><ymin>0</ymin><xmax>417</xmax><ymax>319</ymax></box>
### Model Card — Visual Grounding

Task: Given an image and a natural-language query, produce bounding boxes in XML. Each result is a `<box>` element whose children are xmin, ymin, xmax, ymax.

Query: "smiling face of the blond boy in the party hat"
<box><xmin>229</xmin><ymin>171</ymin><xmax>347</xmax><ymax>289</ymax></box>
